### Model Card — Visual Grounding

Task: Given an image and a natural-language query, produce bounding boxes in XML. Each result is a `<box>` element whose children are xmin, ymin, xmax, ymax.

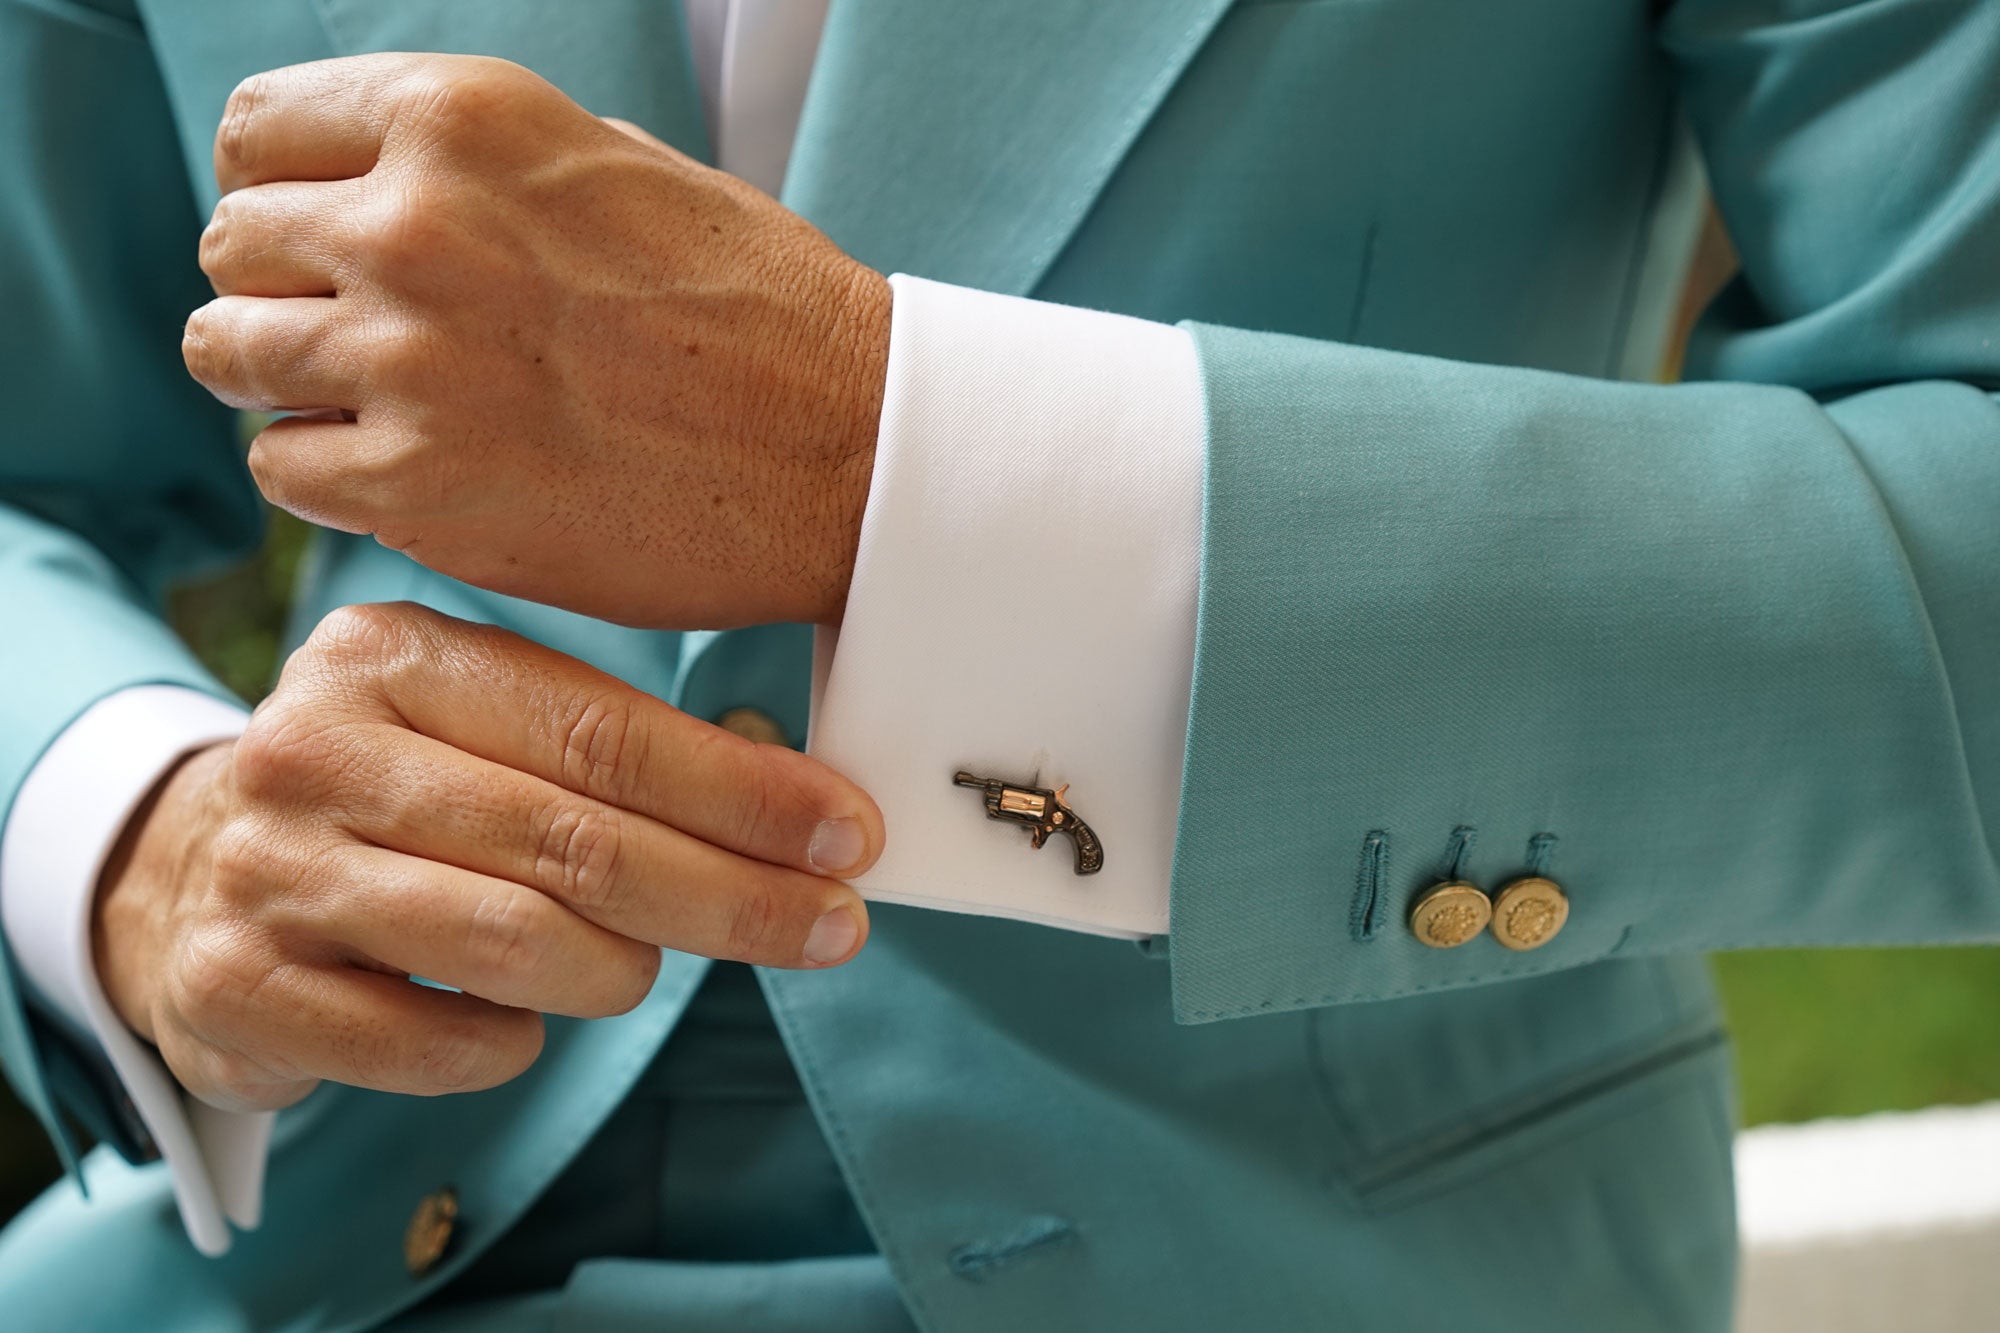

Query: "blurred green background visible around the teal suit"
<box><xmin>0</xmin><ymin>218</ymin><xmax>2000</xmax><ymax>1219</ymax></box>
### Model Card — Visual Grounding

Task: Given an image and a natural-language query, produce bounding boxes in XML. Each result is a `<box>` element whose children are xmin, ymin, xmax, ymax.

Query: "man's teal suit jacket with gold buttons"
<box><xmin>0</xmin><ymin>0</ymin><xmax>2000</xmax><ymax>1333</ymax></box>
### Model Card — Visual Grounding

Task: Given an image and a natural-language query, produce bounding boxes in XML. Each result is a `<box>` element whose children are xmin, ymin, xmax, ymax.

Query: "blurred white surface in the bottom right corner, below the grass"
<box><xmin>1736</xmin><ymin>1103</ymin><xmax>2000</xmax><ymax>1333</ymax></box>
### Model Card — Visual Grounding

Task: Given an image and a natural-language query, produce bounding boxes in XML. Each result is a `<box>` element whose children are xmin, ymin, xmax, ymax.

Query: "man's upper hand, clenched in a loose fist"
<box><xmin>184</xmin><ymin>56</ymin><xmax>890</xmax><ymax>628</ymax></box>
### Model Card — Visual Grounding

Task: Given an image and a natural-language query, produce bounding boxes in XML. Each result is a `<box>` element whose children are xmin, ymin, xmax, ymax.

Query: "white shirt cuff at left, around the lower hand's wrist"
<box><xmin>0</xmin><ymin>685</ymin><xmax>274</xmax><ymax>1255</ymax></box>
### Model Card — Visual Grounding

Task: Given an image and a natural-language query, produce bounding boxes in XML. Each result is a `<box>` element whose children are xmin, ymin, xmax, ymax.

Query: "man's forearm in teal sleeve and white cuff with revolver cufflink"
<box><xmin>814</xmin><ymin>280</ymin><xmax>2000</xmax><ymax>1021</ymax></box>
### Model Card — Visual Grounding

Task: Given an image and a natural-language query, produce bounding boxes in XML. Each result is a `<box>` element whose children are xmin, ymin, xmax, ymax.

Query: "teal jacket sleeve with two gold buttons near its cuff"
<box><xmin>1174</xmin><ymin>328</ymin><xmax>2000</xmax><ymax>1021</ymax></box>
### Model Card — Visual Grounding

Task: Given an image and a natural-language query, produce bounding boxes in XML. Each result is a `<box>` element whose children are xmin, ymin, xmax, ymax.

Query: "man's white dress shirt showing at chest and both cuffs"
<box><xmin>0</xmin><ymin>0</ymin><xmax>1206</xmax><ymax>1255</ymax></box>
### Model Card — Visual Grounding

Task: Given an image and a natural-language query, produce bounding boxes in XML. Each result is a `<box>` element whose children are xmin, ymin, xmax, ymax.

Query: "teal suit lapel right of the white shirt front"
<box><xmin>784</xmin><ymin>0</ymin><xmax>1230</xmax><ymax>294</ymax></box>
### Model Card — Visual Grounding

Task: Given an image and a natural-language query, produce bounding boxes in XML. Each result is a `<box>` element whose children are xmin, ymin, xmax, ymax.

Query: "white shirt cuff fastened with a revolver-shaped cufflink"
<box><xmin>808</xmin><ymin>274</ymin><xmax>1206</xmax><ymax>939</ymax></box>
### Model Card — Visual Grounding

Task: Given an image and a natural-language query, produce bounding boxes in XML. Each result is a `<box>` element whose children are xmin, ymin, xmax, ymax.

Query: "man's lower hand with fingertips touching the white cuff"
<box><xmin>96</xmin><ymin>604</ymin><xmax>882</xmax><ymax>1109</ymax></box>
